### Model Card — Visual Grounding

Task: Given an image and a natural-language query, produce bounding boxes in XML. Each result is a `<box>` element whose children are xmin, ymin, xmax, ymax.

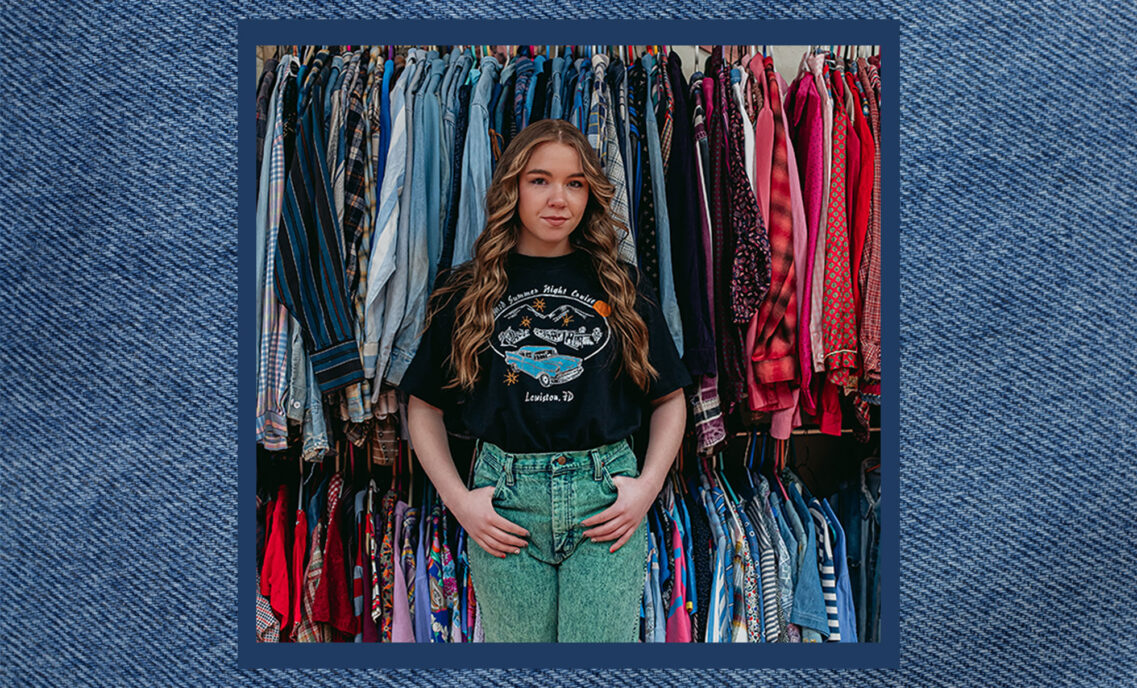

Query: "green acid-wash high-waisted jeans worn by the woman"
<box><xmin>467</xmin><ymin>440</ymin><xmax>647</xmax><ymax>643</ymax></box>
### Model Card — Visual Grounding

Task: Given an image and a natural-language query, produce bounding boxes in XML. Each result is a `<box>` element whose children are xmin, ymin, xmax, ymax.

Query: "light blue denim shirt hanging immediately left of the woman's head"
<box><xmin>451</xmin><ymin>57</ymin><xmax>498</xmax><ymax>265</ymax></box>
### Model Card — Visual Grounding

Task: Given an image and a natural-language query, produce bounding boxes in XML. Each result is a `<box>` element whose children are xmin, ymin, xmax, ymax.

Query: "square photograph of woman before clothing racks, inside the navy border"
<box><xmin>240</xmin><ymin>26</ymin><xmax>897</xmax><ymax>653</ymax></box>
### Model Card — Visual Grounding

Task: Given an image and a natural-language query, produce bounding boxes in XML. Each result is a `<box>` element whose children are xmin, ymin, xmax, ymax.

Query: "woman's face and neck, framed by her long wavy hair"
<box><xmin>517</xmin><ymin>141</ymin><xmax>589</xmax><ymax>256</ymax></box>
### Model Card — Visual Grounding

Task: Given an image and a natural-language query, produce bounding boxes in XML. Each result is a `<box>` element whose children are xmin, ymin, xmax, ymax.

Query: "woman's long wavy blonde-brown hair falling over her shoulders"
<box><xmin>426</xmin><ymin>119</ymin><xmax>658</xmax><ymax>392</ymax></box>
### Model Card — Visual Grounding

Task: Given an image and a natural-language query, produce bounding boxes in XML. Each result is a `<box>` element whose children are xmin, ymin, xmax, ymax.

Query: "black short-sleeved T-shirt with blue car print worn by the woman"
<box><xmin>399</xmin><ymin>250</ymin><xmax>690</xmax><ymax>453</ymax></box>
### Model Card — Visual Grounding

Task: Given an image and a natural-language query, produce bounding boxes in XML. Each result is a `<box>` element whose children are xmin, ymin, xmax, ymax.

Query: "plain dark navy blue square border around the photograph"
<box><xmin>236</xmin><ymin>19</ymin><xmax>901</xmax><ymax>669</ymax></box>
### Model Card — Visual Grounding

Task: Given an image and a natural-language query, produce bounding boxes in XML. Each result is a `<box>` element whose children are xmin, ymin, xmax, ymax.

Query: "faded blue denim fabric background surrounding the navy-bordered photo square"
<box><xmin>0</xmin><ymin>0</ymin><xmax>1137</xmax><ymax>687</ymax></box>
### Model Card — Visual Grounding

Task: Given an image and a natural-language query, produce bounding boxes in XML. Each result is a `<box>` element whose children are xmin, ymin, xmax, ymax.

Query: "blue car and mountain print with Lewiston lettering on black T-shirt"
<box><xmin>490</xmin><ymin>284</ymin><xmax>612</xmax><ymax>403</ymax></box>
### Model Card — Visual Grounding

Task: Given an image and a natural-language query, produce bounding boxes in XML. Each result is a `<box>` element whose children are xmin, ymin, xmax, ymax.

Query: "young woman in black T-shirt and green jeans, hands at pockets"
<box><xmin>400</xmin><ymin>119</ymin><xmax>690</xmax><ymax>643</ymax></box>
